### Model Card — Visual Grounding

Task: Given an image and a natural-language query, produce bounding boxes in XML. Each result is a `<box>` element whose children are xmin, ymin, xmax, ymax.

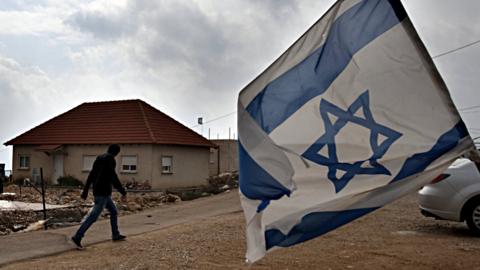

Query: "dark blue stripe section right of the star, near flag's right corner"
<box><xmin>392</xmin><ymin>120</ymin><xmax>468</xmax><ymax>182</ymax></box>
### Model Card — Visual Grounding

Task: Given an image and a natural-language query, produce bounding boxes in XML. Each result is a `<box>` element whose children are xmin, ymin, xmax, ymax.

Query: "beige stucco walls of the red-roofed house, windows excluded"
<box><xmin>12</xmin><ymin>144</ymin><xmax>210</xmax><ymax>189</ymax></box>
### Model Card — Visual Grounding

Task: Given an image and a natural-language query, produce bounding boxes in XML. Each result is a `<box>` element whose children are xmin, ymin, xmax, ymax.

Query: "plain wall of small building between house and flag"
<box><xmin>209</xmin><ymin>140</ymin><xmax>238</xmax><ymax>175</ymax></box>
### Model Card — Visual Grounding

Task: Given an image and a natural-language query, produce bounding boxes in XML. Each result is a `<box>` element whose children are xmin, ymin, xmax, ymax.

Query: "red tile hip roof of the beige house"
<box><xmin>5</xmin><ymin>99</ymin><xmax>213</xmax><ymax>147</ymax></box>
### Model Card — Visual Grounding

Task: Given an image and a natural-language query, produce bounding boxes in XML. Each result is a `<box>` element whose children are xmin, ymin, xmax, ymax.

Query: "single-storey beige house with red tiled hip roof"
<box><xmin>5</xmin><ymin>99</ymin><xmax>214</xmax><ymax>189</ymax></box>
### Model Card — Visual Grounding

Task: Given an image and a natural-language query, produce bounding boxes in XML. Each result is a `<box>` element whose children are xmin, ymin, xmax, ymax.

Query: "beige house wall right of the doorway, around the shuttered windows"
<box><xmin>65</xmin><ymin>144</ymin><xmax>208</xmax><ymax>189</ymax></box>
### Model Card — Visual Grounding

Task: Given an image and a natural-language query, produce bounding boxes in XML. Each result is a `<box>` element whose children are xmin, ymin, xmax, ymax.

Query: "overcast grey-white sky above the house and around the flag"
<box><xmin>0</xmin><ymin>0</ymin><xmax>480</xmax><ymax>168</ymax></box>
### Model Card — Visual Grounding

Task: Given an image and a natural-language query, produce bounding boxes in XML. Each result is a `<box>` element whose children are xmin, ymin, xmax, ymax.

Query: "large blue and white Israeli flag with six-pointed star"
<box><xmin>238</xmin><ymin>0</ymin><xmax>473</xmax><ymax>262</ymax></box>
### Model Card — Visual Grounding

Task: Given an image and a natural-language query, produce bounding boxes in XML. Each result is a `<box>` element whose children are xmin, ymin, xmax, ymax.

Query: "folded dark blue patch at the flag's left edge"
<box><xmin>238</xmin><ymin>143</ymin><xmax>291</xmax><ymax>202</ymax></box>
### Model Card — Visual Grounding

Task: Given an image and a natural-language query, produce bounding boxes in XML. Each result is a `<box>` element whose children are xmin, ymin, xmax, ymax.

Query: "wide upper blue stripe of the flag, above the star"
<box><xmin>247</xmin><ymin>0</ymin><xmax>406</xmax><ymax>133</ymax></box>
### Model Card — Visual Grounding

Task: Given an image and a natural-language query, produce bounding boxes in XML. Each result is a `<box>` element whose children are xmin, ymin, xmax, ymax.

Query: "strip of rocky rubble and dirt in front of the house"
<box><xmin>0</xmin><ymin>172</ymin><xmax>238</xmax><ymax>235</ymax></box>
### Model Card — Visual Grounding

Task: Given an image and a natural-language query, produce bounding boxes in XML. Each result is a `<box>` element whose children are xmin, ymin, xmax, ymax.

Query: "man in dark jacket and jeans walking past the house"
<box><xmin>72</xmin><ymin>144</ymin><xmax>127</xmax><ymax>249</ymax></box>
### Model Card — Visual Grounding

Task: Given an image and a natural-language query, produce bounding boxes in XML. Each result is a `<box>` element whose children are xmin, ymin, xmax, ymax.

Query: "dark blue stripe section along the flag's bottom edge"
<box><xmin>265</xmin><ymin>207</ymin><xmax>378</xmax><ymax>250</ymax></box>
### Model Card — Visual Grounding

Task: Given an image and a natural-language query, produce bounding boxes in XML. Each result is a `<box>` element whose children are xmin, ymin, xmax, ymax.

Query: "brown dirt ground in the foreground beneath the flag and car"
<box><xmin>2</xmin><ymin>191</ymin><xmax>480</xmax><ymax>269</ymax></box>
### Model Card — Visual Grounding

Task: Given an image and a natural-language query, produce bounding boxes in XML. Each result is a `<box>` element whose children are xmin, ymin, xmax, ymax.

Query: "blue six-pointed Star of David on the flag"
<box><xmin>302</xmin><ymin>90</ymin><xmax>402</xmax><ymax>193</ymax></box>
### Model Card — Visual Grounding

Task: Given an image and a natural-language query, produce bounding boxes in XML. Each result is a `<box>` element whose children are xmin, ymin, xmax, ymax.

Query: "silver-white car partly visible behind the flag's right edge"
<box><xmin>418</xmin><ymin>158</ymin><xmax>480</xmax><ymax>236</ymax></box>
